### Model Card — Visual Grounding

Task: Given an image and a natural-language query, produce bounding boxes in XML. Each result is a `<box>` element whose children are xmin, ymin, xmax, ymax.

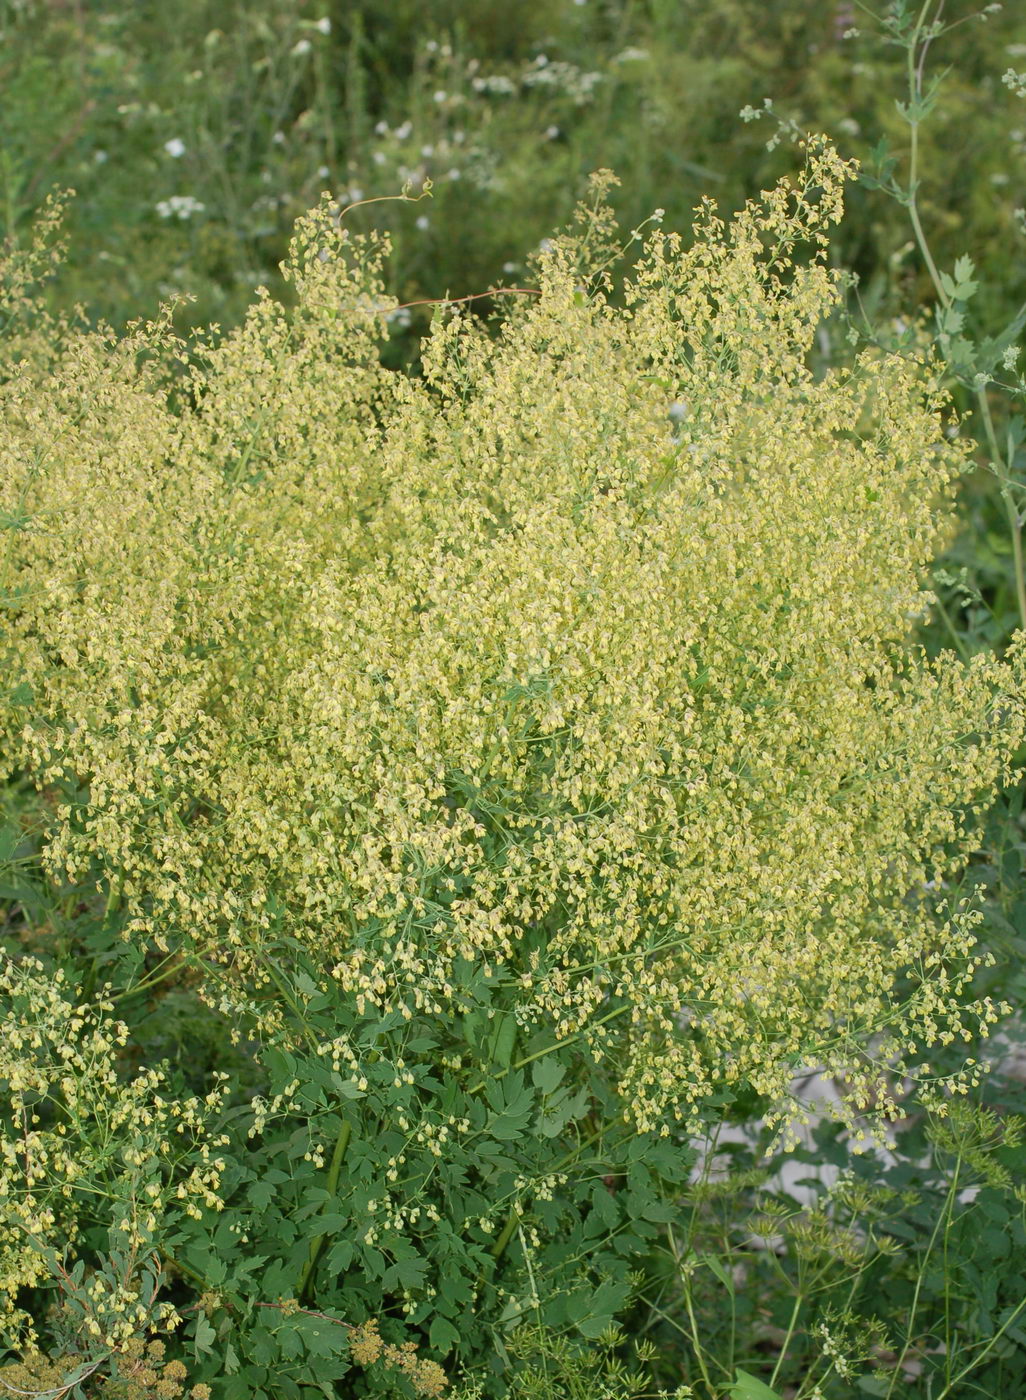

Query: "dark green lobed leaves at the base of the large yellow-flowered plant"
<box><xmin>163</xmin><ymin>967</ymin><xmax>690</xmax><ymax>1396</ymax></box>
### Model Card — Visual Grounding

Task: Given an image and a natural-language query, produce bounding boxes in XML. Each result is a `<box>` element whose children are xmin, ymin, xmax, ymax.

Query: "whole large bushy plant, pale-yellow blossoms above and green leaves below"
<box><xmin>0</xmin><ymin>143</ymin><xmax>1023</xmax><ymax>1400</ymax></box>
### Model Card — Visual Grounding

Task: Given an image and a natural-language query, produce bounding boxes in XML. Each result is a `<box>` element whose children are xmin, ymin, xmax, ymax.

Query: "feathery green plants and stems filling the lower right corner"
<box><xmin>647</xmin><ymin>1103</ymin><xmax>1026</xmax><ymax>1400</ymax></box>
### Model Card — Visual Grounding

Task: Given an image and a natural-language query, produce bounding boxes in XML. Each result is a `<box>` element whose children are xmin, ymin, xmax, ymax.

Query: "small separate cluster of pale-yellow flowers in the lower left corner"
<box><xmin>0</xmin><ymin>959</ymin><xmax>227</xmax><ymax>1347</ymax></box>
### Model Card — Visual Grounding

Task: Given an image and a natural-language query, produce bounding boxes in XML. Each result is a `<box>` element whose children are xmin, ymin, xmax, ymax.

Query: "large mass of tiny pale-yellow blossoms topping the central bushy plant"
<box><xmin>0</xmin><ymin>133</ymin><xmax>1023</xmax><ymax>1127</ymax></box>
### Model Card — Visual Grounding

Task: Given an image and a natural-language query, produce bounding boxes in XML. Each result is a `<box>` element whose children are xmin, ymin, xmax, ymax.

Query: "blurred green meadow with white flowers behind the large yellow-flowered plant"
<box><xmin>0</xmin><ymin>0</ymin><xmax>1026</xmax><ymax>330</ymax></box>
